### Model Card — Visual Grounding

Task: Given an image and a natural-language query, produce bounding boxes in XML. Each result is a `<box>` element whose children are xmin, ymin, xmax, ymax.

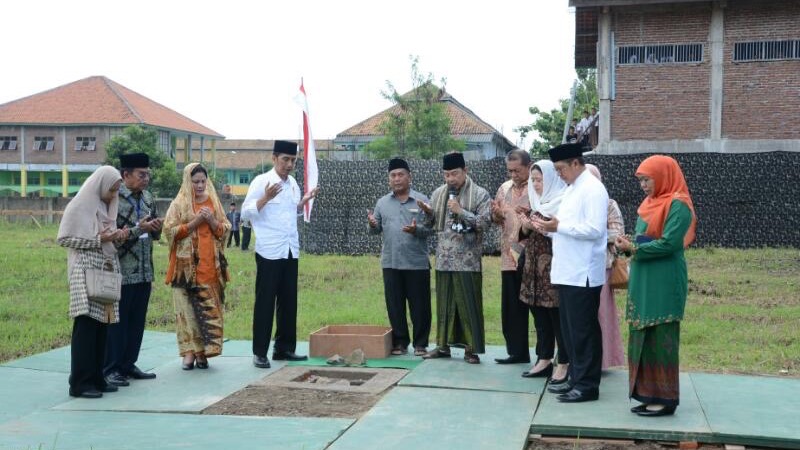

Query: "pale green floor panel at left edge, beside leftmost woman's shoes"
<box><xmin>0</xmin><ymin>367</ymin><xmax>70</xmax><ymax>424</ymax></box>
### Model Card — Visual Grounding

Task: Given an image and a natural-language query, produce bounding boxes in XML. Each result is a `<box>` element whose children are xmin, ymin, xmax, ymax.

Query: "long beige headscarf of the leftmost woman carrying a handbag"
<box><xmin>58</xmin><ymin>166</ymin><xmax>122</xmax><ymax>257</ymax></box>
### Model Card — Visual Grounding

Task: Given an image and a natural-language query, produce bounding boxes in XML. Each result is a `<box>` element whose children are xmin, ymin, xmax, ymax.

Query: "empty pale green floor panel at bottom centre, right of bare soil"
<box><xmin>330</xmin><ymin>387</ymin><xmax>538</xmax><ymax>450</ymax></box>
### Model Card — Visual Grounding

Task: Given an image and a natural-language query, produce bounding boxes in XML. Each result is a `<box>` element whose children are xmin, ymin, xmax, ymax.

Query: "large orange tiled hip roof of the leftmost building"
<box><xmin>0</xmin><ymin>76</ymin><xmax>223</xmax><ymax>138</ymax></box>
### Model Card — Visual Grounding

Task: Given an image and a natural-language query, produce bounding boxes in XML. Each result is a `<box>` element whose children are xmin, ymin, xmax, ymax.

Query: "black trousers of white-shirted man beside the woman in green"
<box><xmin>558</xmin><ymin>285</ymin><xmax>603</xmax><ymax>392</ymax></box>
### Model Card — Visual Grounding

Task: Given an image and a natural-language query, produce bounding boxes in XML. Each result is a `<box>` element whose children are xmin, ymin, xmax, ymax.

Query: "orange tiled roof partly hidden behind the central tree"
<box><xmin>336</xmin><ymin>90</ymin><xmax>500</xmax><ymax>138</ymax></box>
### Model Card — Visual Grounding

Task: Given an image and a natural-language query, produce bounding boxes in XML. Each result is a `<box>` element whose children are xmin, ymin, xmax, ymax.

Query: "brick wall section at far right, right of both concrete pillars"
<box><xmin>722</xmin><ymin>0</ymin><xmax>800</xmax><ymax>139</ymax></box>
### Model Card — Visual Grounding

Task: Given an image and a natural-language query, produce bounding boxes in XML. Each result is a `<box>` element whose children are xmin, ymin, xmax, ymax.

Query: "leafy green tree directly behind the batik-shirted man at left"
<box><xmin>105</xmin><ymin>125</ymin><xmax>181</xmax><ymax>198</ymax></box>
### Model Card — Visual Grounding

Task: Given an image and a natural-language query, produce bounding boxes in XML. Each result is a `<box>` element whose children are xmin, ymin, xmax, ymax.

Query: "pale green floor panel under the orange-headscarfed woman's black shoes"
<box><xmin>531</xmin><ymin>370</ymin><xmax>714</xmax><ymax>442</ymax></box>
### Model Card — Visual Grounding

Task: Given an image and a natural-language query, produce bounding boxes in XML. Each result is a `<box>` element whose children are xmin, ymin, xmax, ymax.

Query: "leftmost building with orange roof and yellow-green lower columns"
<box><xmin>0</xmin><ymin>76</ymin><xmax>224</xmax><ymax>197</ymax></box>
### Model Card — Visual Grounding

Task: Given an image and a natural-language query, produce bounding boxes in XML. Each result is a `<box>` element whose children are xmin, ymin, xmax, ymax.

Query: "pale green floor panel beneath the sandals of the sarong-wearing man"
<box><xmin>399</xmin><ymin>347</ymin><xmax>545</xmax><ymax>394</ymax></box>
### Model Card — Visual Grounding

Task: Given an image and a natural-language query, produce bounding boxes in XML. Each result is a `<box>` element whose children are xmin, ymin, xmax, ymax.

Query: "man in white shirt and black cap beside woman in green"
<box><xmin>534</xmin><ymin>144</ymin><xmax>608</xmax><ymax>403</ymax></box>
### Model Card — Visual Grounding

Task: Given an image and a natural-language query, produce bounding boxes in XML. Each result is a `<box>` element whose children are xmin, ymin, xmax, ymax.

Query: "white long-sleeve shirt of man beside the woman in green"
<box><xmin>550</xmin><ymin>170</ymin><xmax>608</xmax><ymax>287</ymax></box>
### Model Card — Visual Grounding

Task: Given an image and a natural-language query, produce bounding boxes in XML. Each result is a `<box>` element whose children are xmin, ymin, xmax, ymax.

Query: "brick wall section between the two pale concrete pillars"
<box><xmin>611</xmin><ymin>4</ymin><xmax>711</xmax><ymax>141</ymax></box>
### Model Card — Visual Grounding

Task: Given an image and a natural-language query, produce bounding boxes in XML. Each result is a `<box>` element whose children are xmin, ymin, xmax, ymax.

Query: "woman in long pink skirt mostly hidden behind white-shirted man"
<box><xmin>586</xmin><ymin>164</ymin><xmax>626</xmax><ymax>370</ymax></box>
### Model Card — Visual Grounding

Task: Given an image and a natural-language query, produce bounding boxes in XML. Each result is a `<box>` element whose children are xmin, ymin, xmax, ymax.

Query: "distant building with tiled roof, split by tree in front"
<box><xmin>331</xmin><ymin>85</ymin><xmax>516</xmax><ymax>160</ymax></box>
